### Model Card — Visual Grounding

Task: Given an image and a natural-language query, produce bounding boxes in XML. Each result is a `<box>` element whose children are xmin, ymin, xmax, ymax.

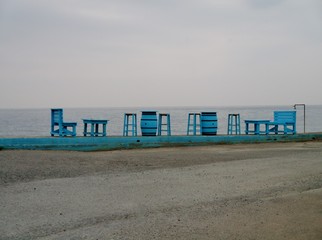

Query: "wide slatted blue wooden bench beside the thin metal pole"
<box><xmin>266</xmin><ymin>111</ymin><xmax>296</xmax><ymax>134</ymax></box>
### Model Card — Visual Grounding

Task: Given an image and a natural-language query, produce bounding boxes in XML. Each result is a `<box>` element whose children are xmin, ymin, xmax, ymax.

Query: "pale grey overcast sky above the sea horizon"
<box><xmin>0</xmin><ymin>0</ymin><xmax>322</xmax><ymax>108</ymax></box>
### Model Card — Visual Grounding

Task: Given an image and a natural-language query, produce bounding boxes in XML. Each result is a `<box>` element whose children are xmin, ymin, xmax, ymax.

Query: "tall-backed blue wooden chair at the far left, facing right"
<box><xmin>50</xmin><ymin>108</ymin><xmax>77</xmax><ymax>137</ymax></box>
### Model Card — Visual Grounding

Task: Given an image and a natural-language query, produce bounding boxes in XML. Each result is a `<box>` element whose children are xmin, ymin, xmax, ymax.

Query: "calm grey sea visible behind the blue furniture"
<box><xmin>0</xmin><ymin>105</ymin><xmax>322</xmax><ymax>137</ymax></box>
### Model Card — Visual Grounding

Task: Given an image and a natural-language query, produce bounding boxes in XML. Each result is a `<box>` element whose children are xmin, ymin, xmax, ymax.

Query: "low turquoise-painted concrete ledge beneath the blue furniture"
<box><xmin>0</xmin><ymin>133</ymin><xmax>322</xmax><ymax>151</ymax></box>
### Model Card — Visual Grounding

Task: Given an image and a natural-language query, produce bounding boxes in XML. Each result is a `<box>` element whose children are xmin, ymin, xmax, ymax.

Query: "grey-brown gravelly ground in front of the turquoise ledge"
<box><xmin>0</xmin><ymin>142</ymin><xmax>322</xmax><ymax>240</ymax></box>
